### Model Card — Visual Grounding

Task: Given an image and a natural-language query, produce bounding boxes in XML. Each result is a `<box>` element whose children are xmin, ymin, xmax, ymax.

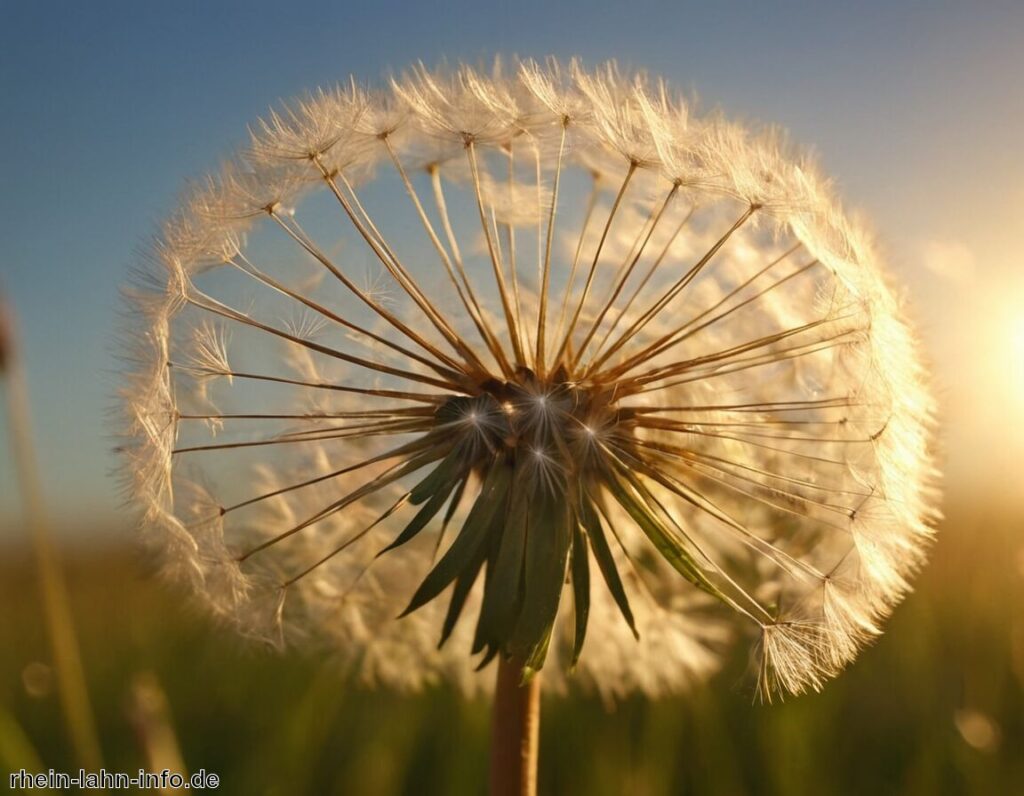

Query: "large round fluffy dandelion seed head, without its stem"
<box><xmin>117</xmin><ymin>55</ymin><xmax>936</xmax><ymax>786</ymax></box>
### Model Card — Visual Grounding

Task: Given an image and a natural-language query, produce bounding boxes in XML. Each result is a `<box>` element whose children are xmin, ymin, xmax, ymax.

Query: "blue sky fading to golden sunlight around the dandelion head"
<box><xmin>0</xmin><ymin>0</ymin><xmax>1024</xmax><ymax>529</ymax></box>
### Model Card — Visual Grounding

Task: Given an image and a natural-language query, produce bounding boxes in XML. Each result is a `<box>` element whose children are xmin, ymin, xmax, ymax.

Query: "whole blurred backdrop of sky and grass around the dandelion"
<box><xmin>0</xmin><ymin>0</ymin><xmax>1024</xmax><ymax>794</ymax></box>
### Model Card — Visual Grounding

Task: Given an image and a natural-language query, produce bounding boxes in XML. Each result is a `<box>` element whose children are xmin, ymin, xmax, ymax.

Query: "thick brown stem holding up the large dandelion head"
<box><xmin>490</xmin><ymin>657</ymin><xmax>541</xmax><ymax>796</ymax></box>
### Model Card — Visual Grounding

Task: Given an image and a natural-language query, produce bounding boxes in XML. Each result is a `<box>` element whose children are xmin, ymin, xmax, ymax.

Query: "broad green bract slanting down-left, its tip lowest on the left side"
<box><xmin>399</xmin><ymin>461</ymin><xmax>511</xmax><ymax>618</ymax></box>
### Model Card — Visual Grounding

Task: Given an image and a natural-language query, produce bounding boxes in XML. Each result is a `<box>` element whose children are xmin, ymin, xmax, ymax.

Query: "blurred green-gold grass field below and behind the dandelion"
<box><xmin>0</xmin><ymin>499</ymin><xmax>1024</xmax><ymax>796</ymax></box>
